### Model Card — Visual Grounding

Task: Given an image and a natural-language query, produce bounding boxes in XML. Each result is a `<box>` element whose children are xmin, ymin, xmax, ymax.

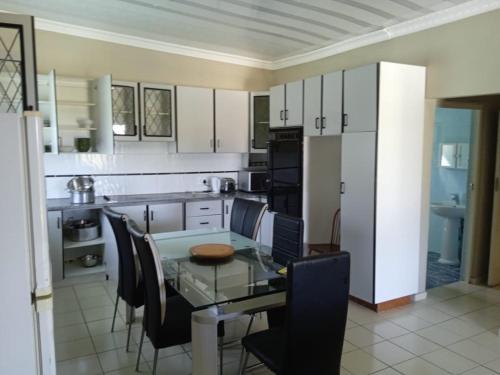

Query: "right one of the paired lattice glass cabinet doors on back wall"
<box><xmin>139</xmin><ymin>83</ymin><xmax>175</xmax><ymax>141</ymax></box>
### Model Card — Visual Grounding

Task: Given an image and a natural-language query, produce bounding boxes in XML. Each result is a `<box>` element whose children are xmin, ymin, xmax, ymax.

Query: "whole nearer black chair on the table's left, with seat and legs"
<box><xmin>127</xmin><ymin>220</ymin><xmax>224</xmax><ymax>374</ymax></box>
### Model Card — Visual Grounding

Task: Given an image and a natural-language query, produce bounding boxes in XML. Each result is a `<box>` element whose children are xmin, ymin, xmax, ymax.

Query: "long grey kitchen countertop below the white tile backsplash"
<box><xmin>47</xmin><ymin>191</ymin><xmax>266</xmax><ymax>211</ymax></box>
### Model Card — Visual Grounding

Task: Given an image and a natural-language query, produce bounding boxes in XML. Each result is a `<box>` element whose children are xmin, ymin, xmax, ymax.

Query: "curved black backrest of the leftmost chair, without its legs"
<box><xmin>103</xmin><ymin>207</ymin><xmax>142</xmax><ymax>307</ymax></box>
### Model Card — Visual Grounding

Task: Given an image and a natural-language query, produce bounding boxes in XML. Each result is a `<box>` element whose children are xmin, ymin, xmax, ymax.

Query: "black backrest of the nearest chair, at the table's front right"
<box><xmin>284</xmin><ymin>252</ymin><xmax>350</xmax><ymax>375</ymax></box>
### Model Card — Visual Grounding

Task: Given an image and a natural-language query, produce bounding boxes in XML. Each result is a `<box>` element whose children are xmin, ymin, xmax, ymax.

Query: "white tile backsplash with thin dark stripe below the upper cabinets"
<box><xmin>45</xmin><ymin>150</ymin><xmax>242</xmax><ymax>198</ymax></box>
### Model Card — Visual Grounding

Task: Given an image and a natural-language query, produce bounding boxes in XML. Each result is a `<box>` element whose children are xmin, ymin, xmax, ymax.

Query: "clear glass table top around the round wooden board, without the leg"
<box><xmin>153</xmin><ymin>229</ymin><xmax>286</xmax><ymax>308</ymax></box>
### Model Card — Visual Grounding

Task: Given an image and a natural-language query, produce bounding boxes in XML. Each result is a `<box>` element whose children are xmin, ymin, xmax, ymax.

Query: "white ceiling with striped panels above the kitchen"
<box><xmin>0</xmin><ymin>0</ymin><xmax>498</xmax><ymax>68</ymax></box>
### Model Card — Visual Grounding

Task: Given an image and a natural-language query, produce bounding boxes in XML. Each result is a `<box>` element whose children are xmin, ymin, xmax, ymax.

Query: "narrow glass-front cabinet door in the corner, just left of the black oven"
<box><xmin>250</xmin><ymin>91</ymin><xmax>269</xmax><ymax>153</ymax></box>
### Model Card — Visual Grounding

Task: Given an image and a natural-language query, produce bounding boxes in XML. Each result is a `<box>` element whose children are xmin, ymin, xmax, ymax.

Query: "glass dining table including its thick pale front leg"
<box><xmin>152</xmin><ymin>229</ymin><xmax>286</xmax><ymax>375</ymax></box>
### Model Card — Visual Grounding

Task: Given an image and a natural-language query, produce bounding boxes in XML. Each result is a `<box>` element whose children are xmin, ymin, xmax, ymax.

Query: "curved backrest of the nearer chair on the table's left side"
<box><xmin>127</xmin><ymin>220</ymin><xmax>167</xmax><ymax>344</ymax></box>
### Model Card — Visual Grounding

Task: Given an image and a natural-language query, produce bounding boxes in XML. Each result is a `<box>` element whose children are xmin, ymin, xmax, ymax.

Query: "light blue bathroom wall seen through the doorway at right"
<box><xmin>428</xmin><ymin>108</ymin><xmax>474</xmax><ymax>253</ymax></box>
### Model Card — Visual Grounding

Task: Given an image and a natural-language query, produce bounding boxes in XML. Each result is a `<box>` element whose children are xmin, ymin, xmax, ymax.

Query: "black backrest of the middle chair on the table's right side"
<box><xmin>272</xmin><ymin>214</ymin><xmax>304</xmax><ymax>266</ymax></box>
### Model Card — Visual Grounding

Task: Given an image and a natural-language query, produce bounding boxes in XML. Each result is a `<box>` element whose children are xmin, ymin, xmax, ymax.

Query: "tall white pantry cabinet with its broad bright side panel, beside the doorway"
<box><xmin>341</xmin><ymin>62</ymin><xmax>425</xmax><ymax>304</ymax></box>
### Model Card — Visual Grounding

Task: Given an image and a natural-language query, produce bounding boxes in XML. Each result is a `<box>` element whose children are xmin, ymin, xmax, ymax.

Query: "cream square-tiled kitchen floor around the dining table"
<box><xmin>54</xmin><ymin>278</ymin><xmax>500</xmax><ymax>375</ymax></box>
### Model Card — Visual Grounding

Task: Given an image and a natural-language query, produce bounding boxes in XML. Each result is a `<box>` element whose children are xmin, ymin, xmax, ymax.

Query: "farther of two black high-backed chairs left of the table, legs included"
<box><xmin>103</xmin><ymin>207</ymin><xmax>144</xmax><ymax>351</ymax></box>
